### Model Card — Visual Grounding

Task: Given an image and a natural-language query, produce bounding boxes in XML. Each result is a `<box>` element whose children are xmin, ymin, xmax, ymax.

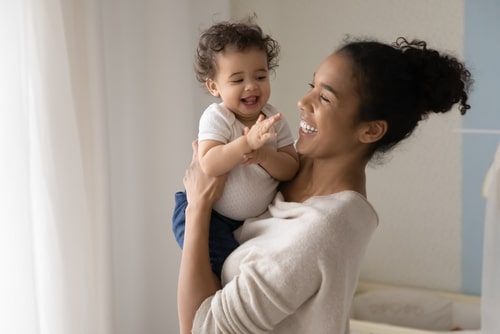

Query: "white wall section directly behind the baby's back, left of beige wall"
<box><xmin>141</xmin><ymin>0</ymin><xmax>228</xmax><ymax>334</ymax></box>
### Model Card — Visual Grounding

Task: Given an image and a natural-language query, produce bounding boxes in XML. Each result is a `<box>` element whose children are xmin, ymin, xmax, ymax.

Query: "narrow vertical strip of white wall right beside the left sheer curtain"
<box><xmin>102</xmin><ymin>0</ymin><xmax>146</xmax><ymax>334</ymax></box>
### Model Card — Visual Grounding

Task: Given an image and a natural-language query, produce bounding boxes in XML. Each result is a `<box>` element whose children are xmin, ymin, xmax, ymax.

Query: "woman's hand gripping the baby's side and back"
<box><xmin>183</xmin><ymin>140</ymin><xmax>227</xmax><ymax>211</ymax></box>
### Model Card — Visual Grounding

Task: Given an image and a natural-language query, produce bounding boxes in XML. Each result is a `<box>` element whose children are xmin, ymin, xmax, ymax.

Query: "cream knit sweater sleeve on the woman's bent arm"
<box><xmin>193</xmin><ymin>247</ymin><xmax>319</xmax><ymax>334</ymax></box>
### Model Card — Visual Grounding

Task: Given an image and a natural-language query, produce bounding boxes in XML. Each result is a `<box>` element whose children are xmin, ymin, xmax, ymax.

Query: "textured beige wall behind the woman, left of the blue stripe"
<box><xmin>230</xmin><ymin>0</ymin><xmax>463</xmax><ymax>291</ymax></box>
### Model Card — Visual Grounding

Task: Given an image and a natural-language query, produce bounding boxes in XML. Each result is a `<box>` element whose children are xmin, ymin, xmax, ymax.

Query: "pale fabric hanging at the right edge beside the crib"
<box><xmin>481</xmin><ymin>143</ymin><xmax>500</xmax><ymax>334</ymax></box>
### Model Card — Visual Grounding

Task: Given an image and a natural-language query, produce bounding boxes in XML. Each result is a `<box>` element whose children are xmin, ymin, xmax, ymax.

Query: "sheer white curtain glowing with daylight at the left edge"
<box><xmin>0</xmin><ymin>0</ymin><xmax>112</xmax><ymax>334</ymax></box>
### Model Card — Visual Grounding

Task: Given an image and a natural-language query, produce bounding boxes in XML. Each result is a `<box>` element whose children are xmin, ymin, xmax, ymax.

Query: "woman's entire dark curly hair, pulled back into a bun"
<box><xmin>337</xmin><ymin>37</ymin><xmax>472</xmax><ymax>156</ymax></box>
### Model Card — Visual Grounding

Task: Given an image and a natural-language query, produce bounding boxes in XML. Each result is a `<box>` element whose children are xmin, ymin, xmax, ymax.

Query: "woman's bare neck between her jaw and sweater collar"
<box><xmin>280</xmin><ymin>158</ymin><xmax>366</xmax><ymax>202</ymax></box>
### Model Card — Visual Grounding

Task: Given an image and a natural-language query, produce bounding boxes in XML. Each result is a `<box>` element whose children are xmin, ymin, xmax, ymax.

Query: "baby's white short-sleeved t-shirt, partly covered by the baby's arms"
<box><xmin>198</xmin><ymin>103</ymin><xmax>294</xmax><ymax>220</ymax></box>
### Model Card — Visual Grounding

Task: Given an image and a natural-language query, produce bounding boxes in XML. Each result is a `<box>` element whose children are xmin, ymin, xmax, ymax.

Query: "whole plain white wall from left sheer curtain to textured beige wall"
<box><xmin>102</xmin><ymin>0</ymin><xmax>229</xmax><ymax>334</ymax></box>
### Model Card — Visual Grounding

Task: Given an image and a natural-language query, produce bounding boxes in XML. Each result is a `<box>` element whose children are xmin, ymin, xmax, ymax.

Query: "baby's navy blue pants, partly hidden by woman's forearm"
<box><xmin>172</xmin><ymin>191</ymin><xmax>243</xmax><ymax>279</ymax></box>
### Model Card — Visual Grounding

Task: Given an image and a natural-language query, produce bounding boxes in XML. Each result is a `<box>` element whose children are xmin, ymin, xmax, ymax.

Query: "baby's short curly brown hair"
<box><xmin>194</xmin><ymin>19</ymin><xmax>280</xmax><ymax>83</ymax></box>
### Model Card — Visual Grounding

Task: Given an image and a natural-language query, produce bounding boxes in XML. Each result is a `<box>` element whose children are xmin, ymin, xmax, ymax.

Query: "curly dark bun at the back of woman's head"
<box><xmin>393</xmin><ymin>37</ymin><xmax>471</xmax><ymax>115</ymax></box>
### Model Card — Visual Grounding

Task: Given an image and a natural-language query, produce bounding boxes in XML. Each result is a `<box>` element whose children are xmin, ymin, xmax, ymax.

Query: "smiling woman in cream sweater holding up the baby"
<box><xmin>178</xmin><ymin>38</ymin><xmax>470</xmax><ymax>334</ymax></box>
